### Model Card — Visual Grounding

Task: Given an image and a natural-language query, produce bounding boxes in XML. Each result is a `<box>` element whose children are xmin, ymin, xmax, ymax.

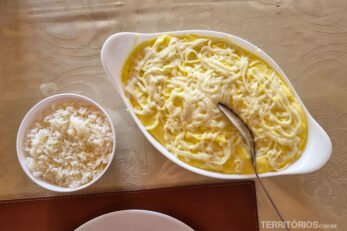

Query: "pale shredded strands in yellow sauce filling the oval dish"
<box><xmin>122</xmin><ymin>35</ymin><xmax>307</xmax><ymax>173</ymax></box>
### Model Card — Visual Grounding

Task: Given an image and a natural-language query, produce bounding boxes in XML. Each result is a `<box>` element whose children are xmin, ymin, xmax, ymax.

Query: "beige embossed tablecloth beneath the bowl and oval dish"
<box><xmin>0</xmin><ymin>0</ymin><xmax>347</xmax><ymax>229</ymax></box>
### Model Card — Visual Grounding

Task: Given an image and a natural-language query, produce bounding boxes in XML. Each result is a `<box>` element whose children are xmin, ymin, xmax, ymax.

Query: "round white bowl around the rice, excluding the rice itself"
<box><xmin>16</xmin><ymin>93</ymin><xmax>116</xmax><ymax>192</ymax></box>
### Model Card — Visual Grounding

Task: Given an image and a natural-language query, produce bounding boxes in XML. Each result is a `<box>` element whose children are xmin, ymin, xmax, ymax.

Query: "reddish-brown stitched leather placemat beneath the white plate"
<box><xmin>0</xmin><ymin>181</ymin><xmax>259</xmax><ymax>231</ymax></box>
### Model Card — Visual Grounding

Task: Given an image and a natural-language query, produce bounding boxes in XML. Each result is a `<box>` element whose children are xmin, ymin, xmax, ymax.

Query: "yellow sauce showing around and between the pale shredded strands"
<box><xmin>122</xmin><ymin>35</ymin><xmax>307</xmax><ymax>174</ymax></box>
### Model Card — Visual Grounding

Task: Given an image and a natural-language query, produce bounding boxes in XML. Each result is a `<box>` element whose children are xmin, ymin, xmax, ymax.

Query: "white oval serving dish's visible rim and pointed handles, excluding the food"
<box><xmin>101</xmin><ymin>30</ymin><xmax>332</xmax><ymax>179</ymax></box>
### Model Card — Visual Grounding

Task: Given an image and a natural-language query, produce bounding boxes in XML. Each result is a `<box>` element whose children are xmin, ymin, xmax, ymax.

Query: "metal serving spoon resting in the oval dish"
<box><xmin>218</xmin><ymin>103</ymin><xmax>290</xmax><ymax>230</ymax></box>
